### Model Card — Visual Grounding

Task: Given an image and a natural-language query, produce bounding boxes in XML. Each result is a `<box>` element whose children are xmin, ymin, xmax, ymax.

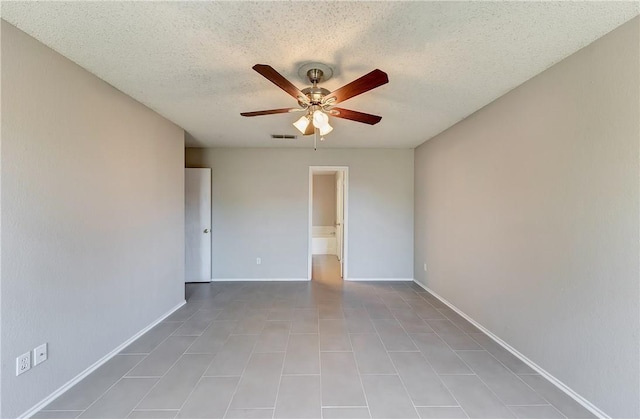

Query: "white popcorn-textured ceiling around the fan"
<box><xmin>1</xmin><ymin>1</ymin><xmax>639</xmax><ymax>147</ymax></box>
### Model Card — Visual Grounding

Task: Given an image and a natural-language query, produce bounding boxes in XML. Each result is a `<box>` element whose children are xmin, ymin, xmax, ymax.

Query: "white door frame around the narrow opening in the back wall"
<box><xmin>307</xmin><ymin>166</ymin><xmax>349</xmax><ymax>281</ymax></box>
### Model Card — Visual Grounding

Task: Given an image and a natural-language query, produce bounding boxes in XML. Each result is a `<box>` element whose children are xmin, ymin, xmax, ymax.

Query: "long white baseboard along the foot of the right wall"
<box><xmin>414</xmin><ymin>280</ymin><xmax>611</xmax><ymax>419</ymax></box>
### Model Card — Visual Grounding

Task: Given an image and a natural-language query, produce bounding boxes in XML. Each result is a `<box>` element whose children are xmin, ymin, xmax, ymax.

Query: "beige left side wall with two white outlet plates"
<box><xmin>0</xmin><ymin>21</ymin><xmax>184</xmax><ymax>418</ymax></box>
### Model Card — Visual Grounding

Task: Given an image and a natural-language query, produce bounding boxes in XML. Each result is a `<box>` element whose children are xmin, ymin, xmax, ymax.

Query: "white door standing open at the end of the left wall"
<box><xmin>184</xmin><ymin>168</ymin><xmax>211</xmax><ymax>282</ymax></box>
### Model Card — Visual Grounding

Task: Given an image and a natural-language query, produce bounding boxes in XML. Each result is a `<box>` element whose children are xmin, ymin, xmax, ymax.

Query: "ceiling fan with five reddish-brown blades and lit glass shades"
<box><xmin>240</xmin><ymin>63</ymin><xmax>389</xmax><ymax>140</ymax></box>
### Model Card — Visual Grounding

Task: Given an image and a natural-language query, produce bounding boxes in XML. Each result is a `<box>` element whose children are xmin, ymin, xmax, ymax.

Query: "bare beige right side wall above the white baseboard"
<box><xmin>415</xmin><ymin>18</ymin><xmax>640</xmax><ymax>417</ymax></box>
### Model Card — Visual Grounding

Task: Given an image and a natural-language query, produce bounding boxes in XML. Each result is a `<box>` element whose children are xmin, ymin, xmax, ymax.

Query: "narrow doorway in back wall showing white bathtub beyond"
<box><xmin>308</xmin><ymin>166</ymin><xmax>349</xmax><ymax>281</ymax></box>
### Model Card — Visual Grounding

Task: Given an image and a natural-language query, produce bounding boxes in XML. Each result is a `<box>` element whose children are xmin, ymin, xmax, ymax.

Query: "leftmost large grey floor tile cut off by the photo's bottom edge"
<box><xmin>78</xmin><ymin>378</ymin><xmax>158</xmax><ymax>419</ymax></box>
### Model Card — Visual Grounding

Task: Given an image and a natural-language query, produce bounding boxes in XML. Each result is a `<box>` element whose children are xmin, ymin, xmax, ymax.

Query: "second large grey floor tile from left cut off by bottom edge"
<box><xmin>178</xmin><ymin>377</ymin><xmax>240</xmax><ymax>419</ymax></box>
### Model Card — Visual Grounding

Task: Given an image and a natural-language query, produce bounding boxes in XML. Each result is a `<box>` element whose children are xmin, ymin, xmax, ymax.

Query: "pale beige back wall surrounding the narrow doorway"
<box><xmin>186</xmin><ymin>144</ymin><xmax>413</xmax><ymax>279</ymax></box>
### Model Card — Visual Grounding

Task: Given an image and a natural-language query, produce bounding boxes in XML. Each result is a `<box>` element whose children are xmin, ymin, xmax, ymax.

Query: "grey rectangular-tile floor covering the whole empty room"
<box><xmin>34</xmin><ymin>258</ymin><xmax>593</xmax><ymax>419</ymax></box>
